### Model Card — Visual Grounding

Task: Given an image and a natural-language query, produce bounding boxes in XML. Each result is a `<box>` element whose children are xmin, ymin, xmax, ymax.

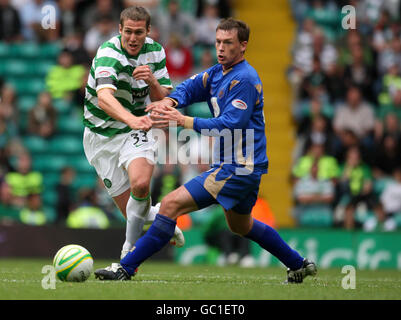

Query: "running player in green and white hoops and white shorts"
<box><xmin>83</xmin><ymin>7</ymin><xmax>184</xmax><ymax>264</ymax></box>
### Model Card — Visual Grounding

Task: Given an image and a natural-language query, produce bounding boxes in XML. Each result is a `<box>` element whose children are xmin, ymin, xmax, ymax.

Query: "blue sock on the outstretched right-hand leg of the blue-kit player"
<box><xmin>245</xmin><ymin>219</ymin><xmax>304</xmax><ymax>270</ymax></box>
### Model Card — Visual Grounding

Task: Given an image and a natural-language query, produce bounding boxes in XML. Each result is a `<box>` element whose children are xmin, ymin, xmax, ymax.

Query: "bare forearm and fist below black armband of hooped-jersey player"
<box><xmin>97</xmin><ymin>88</ymin><xmax>153</xmax><ymax>131</ymax></box>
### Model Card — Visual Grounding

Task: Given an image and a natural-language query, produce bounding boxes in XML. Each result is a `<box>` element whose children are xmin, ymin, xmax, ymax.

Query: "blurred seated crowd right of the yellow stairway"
<box><xmin>287</xmin><ymin>0</ymin><xmax>401</xmax><ymax>231</ymax></box>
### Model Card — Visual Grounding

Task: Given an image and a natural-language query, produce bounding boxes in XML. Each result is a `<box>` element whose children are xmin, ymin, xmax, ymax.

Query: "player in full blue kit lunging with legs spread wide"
<box><xmin>95</xmin><ymin>18</ymin><xmax>317</xmax><ymax>283</ymax></box>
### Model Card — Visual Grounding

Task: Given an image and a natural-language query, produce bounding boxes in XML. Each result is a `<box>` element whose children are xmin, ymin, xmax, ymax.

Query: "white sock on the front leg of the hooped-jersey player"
<box><xmin>122</xmin><ymin>195</ymin><xmax>151</xmax><ymax>252</ymax></box>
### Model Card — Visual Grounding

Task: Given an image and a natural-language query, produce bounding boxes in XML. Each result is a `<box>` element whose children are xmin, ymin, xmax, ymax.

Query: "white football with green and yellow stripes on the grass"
<box><xmin>53</xmin><ymin>244</ymin><xmax>93</xmax><ymax>282</ymax></box>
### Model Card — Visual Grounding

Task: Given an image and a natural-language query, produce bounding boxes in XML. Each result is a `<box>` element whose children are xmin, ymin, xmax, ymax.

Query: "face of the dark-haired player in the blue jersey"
<box><xmin>216</xmin><ymin>29</ymin><xmax>247</xmax><ymax>70</ymax></box>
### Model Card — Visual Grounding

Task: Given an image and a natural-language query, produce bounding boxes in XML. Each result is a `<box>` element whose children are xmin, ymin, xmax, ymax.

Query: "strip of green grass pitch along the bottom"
<box><xmin>0</xmin><ymin>259</ymin><xmax>401</xmax><ymax>300</ymax></box>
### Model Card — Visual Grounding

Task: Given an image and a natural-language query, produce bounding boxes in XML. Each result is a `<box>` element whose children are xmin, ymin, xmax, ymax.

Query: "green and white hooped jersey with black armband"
<box><xmin>83</xmin><ymin>35</ymin><xmax>173</xmax><ymax>137</ymax></box>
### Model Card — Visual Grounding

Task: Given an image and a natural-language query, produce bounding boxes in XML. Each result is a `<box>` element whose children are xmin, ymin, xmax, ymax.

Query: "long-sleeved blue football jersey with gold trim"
<box><xmin>169</xmin><ymin>60</ymin><xmax>268</xmax><ymax>172</ymax></box>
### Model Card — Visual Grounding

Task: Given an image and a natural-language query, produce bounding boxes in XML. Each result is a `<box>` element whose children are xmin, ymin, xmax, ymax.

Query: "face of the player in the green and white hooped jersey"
<box><xmin>120</xmin><ymin>20</ymin><xmax>150</xmax><ymax>56</ymax></box>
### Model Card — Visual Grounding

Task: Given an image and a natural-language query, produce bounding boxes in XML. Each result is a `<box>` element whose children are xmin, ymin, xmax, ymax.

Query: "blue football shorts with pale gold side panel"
<box><xmin>184</xmin><ymin>165</ymin><xmax>265</xmax><ymax>214</ymax></box>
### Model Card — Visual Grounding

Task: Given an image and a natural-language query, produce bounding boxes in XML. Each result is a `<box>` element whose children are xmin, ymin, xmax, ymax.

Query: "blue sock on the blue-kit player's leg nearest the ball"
<box><xmin>120</xmin><ymin>214</ymin><xmax>176</xmax><ymax>275</ymax></box>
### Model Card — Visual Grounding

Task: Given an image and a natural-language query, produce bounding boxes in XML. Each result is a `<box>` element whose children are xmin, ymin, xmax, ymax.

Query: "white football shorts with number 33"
<box><xmin>83</xmin><ymin>128</ymin><xmax>155</xmax><ymax>197</ymax></box>
